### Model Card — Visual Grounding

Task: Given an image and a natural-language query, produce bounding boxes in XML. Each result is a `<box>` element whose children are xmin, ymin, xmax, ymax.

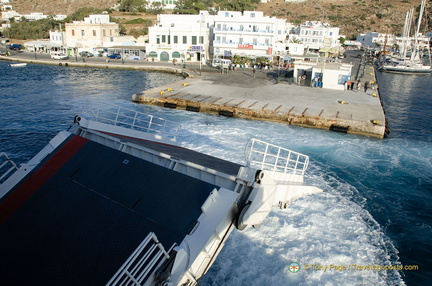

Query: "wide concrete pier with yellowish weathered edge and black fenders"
<box><xmin>132</xmin><ymin>56</ymin><xmax>386</xmax><ymax>138</ymax></box>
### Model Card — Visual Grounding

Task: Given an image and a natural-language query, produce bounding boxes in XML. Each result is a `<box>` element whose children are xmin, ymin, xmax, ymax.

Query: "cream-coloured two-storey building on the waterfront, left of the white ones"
<box><xmin>65</xmin><ymin>15</ymin><xmax>119</xmax><ymax>49</ymax></box>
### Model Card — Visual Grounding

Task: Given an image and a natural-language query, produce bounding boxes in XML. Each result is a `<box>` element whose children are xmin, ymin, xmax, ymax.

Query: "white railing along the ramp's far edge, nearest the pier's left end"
<box><xmin>92</xmin><ymin>102</ymin><xmax>180</xmax><ymax>139</ymax></box>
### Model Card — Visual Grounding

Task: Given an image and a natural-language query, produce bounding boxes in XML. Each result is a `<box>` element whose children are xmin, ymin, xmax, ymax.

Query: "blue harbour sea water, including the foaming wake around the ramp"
<box><xmin>0</xmin><ymin>62</ymin><xmax>432</xmax><ymax>285</ymax></box>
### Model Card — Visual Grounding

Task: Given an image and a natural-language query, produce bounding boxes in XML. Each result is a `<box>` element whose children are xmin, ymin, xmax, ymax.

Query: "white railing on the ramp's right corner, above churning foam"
<box><xmin>245</xmin><ymin>139</ymin><xmax>309</xmax><ymax>175</ymax></box>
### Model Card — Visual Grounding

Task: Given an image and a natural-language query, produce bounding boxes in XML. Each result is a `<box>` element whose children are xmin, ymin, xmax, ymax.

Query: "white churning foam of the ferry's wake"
<box><xmin>165</xmin><ymin>108</ymin><xmax>403</xmax><ymax>285</ymax></box>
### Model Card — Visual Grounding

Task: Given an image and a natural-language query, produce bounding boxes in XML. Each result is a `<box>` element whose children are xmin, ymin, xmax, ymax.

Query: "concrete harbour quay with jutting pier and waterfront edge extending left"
<box><xmin>0</xmin><ymin>49</ymin><xmax>386</xmax><ymax>138</ymax></box>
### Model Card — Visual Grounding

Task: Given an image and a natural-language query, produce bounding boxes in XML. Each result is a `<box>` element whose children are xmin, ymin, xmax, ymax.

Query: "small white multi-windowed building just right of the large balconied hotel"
<box><xmin>298</xmin><ymin>21</ymin><xmax>340</xmax><ymax>51</ymax></box>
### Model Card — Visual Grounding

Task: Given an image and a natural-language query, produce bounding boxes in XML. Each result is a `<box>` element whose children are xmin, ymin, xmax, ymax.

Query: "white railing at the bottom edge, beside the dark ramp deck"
<box><xmin>106</xmin><ymin>232</ymin><xmax>170</xmax><ymax>286</ymax></box>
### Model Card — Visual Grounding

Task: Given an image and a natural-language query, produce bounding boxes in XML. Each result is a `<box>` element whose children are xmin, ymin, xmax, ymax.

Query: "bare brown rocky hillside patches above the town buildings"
<box><xmin>6</xmin><ymin>0</ymin><xmax>432</xmax><ymax>38</ymax></box>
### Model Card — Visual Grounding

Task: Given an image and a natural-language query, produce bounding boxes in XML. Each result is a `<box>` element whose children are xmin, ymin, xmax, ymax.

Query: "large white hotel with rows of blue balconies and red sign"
<box><xmin>213</xmin><ymin>11</ymin><xmax>286</xmax><ymax>58</ymax></box>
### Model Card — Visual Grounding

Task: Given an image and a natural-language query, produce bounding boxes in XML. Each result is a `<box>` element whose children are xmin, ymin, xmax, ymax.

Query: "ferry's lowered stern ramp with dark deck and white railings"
<box><xmin>0</xmin><ymin>101</ymin><xmax>322</xmax><ymax>286</ymax></box>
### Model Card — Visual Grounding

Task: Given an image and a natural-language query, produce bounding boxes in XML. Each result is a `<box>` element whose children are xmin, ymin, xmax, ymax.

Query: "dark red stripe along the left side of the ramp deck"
<box><xmin>0</xmin><ymin>136</ymin><xmax>88</xmax><ymax>224</ymax></box>
